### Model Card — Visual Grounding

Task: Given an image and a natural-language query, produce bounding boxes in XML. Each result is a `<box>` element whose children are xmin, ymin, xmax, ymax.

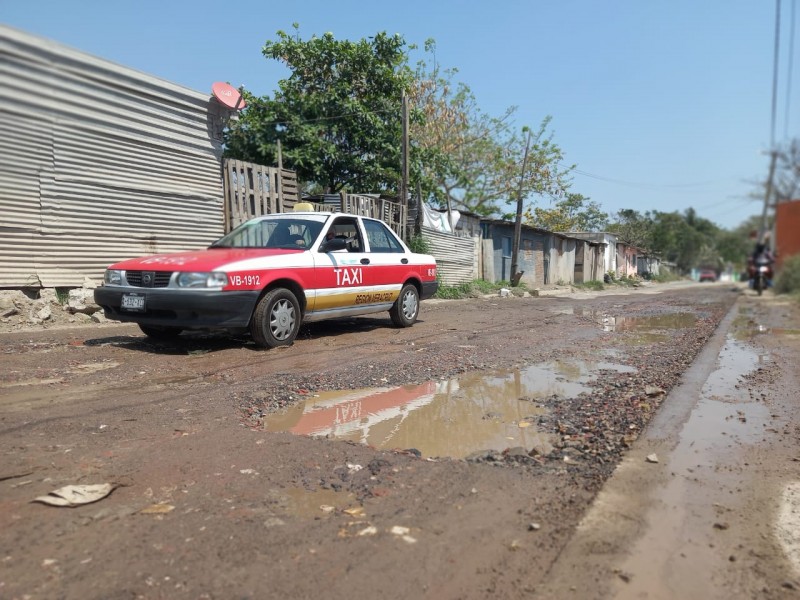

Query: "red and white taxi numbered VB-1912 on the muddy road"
<box><xmin>94</xmin><ymin>212</ymin><xmax>438</xmax><ymax>348</ymax></box>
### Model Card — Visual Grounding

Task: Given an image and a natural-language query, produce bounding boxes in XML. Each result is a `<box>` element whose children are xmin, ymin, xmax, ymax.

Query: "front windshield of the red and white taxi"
<box><xmin>209</xmin><ymin>216</ymin><xmax>326</xmax><ymax>250</ymax></box>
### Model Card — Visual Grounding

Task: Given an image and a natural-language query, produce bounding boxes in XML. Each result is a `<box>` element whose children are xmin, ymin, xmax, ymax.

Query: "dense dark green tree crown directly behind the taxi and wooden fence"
<box><xmin>225</xmin><ymin>24</ymin><xmax>410</xmax><ymax>192</ymax></box>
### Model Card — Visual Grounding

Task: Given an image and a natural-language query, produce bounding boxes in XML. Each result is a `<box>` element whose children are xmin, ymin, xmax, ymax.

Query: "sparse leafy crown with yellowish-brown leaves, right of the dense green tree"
<box><xmin>410</xmin><ymin>45</ymin><xmax>569</xmax><ymax>215</ymax></box>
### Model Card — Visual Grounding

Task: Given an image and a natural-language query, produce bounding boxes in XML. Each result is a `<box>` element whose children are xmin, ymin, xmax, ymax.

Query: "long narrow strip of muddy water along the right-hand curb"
<box><xmin>616</xmin><ymin>333</ymin><xmax>770</xmax><ymax>598</ymax></box>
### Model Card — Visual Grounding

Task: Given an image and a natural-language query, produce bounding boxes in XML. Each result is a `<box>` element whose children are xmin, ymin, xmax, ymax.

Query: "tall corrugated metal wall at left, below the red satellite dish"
<box><xmin>0</xmin><ymin>25</ymin><xmax>226</xmax><ymax>288</ymax></box>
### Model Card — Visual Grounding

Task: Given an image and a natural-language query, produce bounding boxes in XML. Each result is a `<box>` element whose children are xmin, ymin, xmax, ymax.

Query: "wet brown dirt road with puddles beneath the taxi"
<box><xmin>0</xmin><ymin>284</ymin><xmax>800</xmax><ymax>600</ymax></box>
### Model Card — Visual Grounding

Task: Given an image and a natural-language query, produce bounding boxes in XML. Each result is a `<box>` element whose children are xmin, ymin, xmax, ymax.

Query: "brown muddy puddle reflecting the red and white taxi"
<box><xmin>264</xmin><ymin>360</ymin><xmax>635</xmax><ymax>458</ymax></box>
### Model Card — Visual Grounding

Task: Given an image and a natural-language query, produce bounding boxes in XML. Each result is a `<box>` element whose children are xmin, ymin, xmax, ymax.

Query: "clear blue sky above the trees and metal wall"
<box><xmin>0</xmin><ymin>0</ymin><xmax>800</xmax><ymax>228</ymax></box>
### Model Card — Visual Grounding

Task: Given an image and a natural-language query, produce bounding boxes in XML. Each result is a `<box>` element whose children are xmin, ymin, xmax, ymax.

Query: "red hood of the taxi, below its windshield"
<box><xmin>109</xmin><ymin>248</ymin><xmax>304</xmax><ymax>271</ymax></box>
